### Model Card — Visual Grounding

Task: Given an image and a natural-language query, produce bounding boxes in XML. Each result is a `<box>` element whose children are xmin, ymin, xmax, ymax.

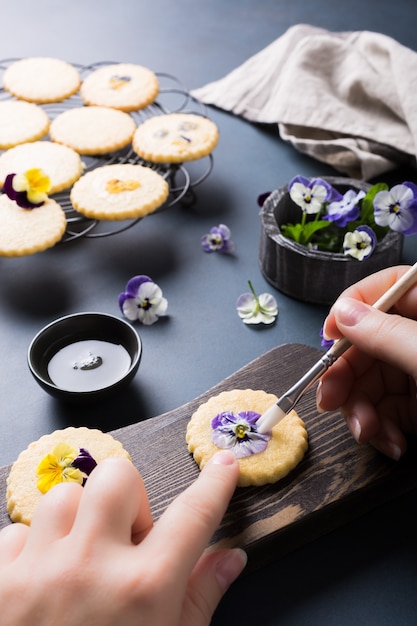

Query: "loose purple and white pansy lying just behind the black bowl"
<box><xmin>119</xmin><ymin>275</ymin><xmax>168</xmax><ymax>326</ymax></box>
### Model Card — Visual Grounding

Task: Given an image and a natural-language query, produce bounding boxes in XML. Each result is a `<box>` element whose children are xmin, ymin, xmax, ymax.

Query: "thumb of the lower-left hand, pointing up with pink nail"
<box><xmin>181</xmin><ymin>549</ymin><xmax>247</xmax><ymax>626</ymax></box>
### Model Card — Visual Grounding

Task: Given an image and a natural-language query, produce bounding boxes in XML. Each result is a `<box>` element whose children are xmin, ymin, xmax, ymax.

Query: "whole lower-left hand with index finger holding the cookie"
<box><xmin>0</xmin><ymin>451</ymin><xmax>246</xmax><ymax>626</ymax></box>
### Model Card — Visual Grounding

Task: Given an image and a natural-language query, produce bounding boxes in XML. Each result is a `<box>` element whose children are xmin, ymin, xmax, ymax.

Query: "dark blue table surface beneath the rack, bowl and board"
<box><xmin>0</xmin><ymin>0</ymin><xmax>417</xmax><ymax>626</ymax></box>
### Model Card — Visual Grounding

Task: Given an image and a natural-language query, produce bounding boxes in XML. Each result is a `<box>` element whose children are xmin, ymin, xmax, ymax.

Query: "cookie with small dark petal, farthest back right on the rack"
<box><xmin>80</xmin><ymin>63</ymin><xmax>159</xmax><ymax>112</ymax></box>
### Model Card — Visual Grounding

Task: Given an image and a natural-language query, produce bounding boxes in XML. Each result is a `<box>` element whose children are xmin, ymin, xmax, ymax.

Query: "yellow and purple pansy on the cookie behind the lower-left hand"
<box><xmin>36</xmin><ymin>442</ymin><xmax>97</xmax><ymax>493</ymax></box>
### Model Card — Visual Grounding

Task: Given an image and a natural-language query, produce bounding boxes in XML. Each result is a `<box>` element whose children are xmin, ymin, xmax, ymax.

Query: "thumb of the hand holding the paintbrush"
<box><xmin>332</xmin><ymin>298</ymin><xmax>417</xmax><ymax>379</ymax></box>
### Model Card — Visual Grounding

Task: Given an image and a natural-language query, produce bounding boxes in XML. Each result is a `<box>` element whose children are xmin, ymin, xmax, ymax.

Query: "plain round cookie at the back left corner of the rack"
<box><xmin>3</xmin><ymin>57</ymin><xmax>81</xmax><ymax>104</ymax></box>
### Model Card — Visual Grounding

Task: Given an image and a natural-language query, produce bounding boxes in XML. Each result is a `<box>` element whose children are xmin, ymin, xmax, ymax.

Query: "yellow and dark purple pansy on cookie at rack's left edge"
<box><xmin>3</xmin><ymin>167</ymin><xmax>51</xmax><ymax>209</ymax></box>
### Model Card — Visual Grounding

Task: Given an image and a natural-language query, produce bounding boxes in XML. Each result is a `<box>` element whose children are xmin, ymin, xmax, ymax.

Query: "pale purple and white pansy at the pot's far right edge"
<box><xmin>374</xmin><ymin>182</ymin><xmax>417</xmax><ymax>235</ymax></box>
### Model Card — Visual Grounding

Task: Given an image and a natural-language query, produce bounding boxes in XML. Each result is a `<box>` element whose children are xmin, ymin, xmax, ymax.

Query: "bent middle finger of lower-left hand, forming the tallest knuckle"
<box><xmin>73</xmin><ymin>458</ymin><xmax>153</xmax><ymax>543</ymax></box>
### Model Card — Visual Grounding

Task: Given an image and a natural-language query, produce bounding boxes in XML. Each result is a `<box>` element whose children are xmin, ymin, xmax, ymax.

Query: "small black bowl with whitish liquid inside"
<box><xmin>28</xmin><ymin>312</ymin><xmax>142</xmax><ymax>403</ymax></box>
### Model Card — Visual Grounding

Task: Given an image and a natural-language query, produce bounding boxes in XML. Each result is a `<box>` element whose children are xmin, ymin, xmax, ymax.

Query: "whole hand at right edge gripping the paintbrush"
<box><xmin>317</xmin><ymin>266</ymin><xmax>417</xmax><ymax>460</ymax></box>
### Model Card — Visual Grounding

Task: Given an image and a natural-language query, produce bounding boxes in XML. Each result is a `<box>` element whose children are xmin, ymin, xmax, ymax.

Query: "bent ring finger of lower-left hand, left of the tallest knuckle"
<box><xmin>27</xmin><ymin>483</ymin><xmax>83</xmax><ymax>550</ymax></box>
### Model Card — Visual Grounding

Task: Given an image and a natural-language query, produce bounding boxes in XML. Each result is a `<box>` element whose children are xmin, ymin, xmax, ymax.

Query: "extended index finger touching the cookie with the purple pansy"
<box><xmin>141</xmin><ymin>450</ymin><xmax>239</xmax><ymax>588</ymax></box>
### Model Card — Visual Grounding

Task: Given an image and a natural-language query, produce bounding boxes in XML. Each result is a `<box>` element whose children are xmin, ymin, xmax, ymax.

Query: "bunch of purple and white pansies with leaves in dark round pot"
<box><xmin>272</xmin><ymin>176</ymin><xmax>417</xmax><ymax>261</ymax></box>
